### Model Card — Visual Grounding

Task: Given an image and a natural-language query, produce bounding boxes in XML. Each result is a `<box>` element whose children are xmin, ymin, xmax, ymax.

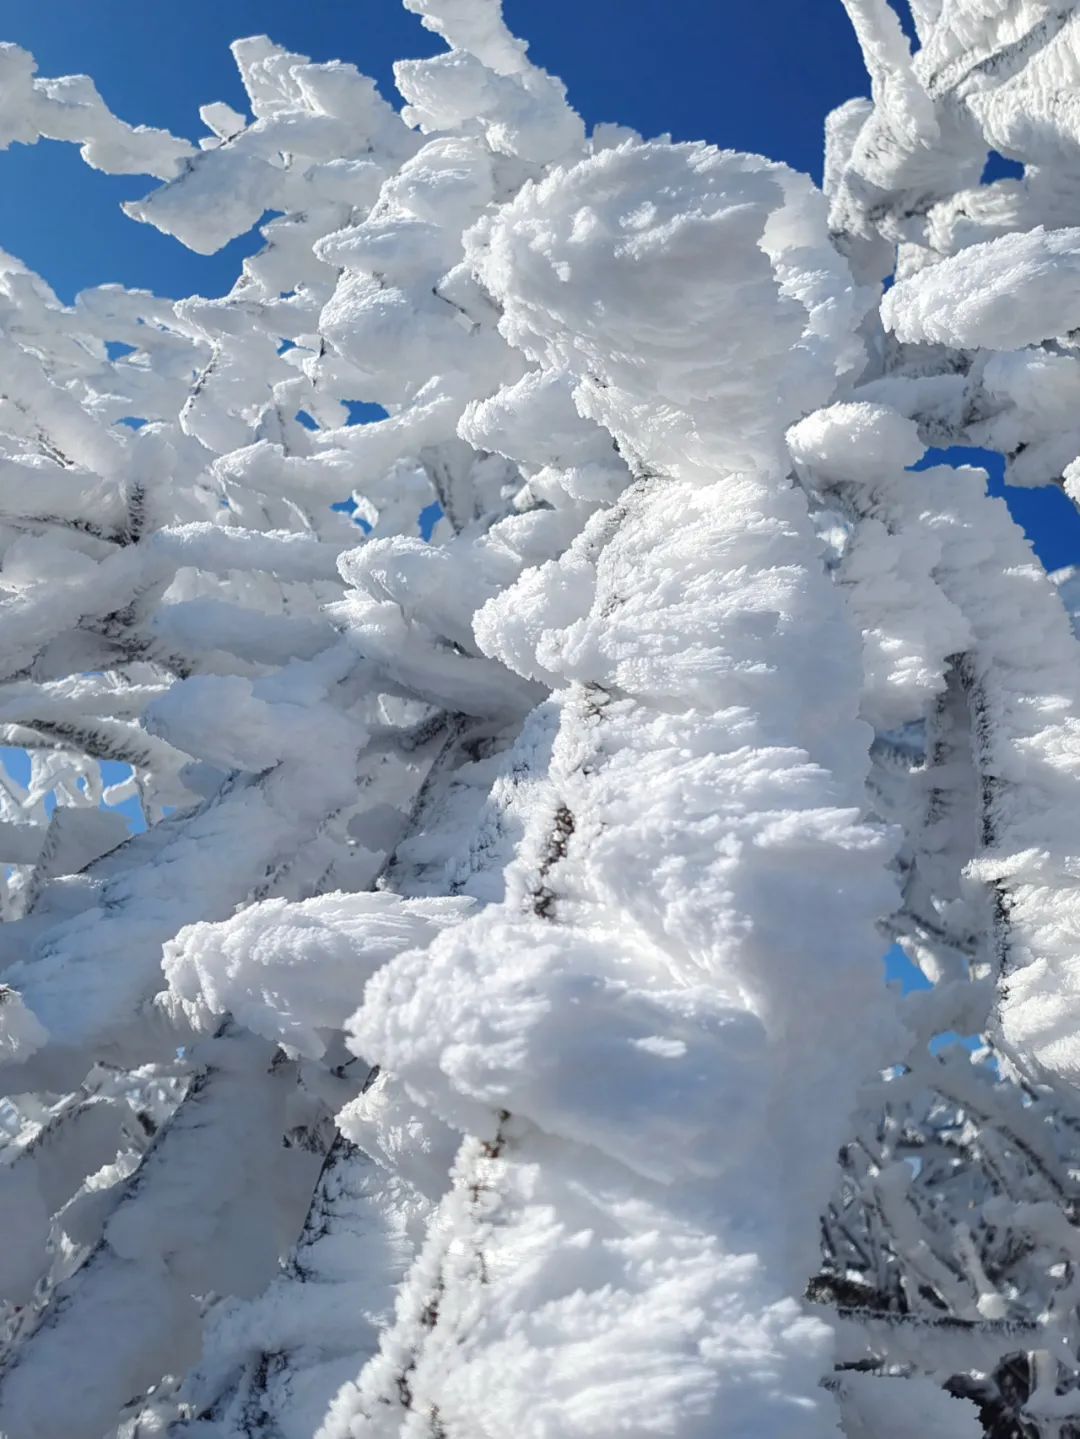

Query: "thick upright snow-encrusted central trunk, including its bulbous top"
<box><xmin>325</xmin><ymin>95</ymin><xmax>890</xmax><ymax>1436</ymax></box>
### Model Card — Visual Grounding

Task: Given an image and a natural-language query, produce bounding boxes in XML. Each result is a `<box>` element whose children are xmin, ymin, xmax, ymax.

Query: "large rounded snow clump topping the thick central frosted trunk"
<box><xmin>469</xmin><ymin>142</ymin><xmax>859</xmax><ymax>469</ymax></box>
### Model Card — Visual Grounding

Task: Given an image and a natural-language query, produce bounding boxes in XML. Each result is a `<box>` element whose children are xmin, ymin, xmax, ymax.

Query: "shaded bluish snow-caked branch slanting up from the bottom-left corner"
<box><xmin>0</xmin><ymin>1038</ymin><xmax>320</xmax><ymax>1439</ymax></box>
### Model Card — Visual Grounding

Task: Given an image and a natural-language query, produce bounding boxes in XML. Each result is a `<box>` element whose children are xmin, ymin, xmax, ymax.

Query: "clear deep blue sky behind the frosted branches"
<box><xmin>0</xmin><ymin>0</ymin><xmax>1080</xmax><ymax>568</ymax></box>
